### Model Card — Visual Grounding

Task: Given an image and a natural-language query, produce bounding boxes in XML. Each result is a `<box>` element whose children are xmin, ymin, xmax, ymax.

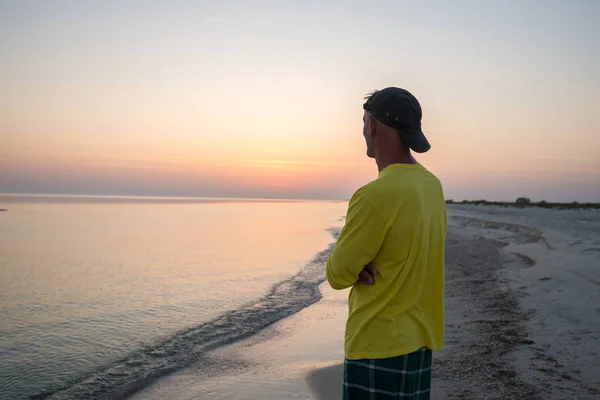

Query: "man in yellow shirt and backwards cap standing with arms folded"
<box><xmin>327</xmin><ymin>87</ymin><xmax>447</xmax><ymax>400</ymax></box>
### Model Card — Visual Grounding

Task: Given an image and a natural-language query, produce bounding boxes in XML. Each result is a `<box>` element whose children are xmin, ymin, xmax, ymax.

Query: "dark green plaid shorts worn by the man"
<box><xmin>343</xmin><ymin>347</ymin><xmax>431</xmax><ymax>400</ymax></box>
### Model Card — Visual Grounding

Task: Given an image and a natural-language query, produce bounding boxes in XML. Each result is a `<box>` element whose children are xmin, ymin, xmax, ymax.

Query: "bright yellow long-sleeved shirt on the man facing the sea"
<box><xmin>327</xmin><ymin>164</ymin><xmax>447</xmax><ymax>360</ymax></box>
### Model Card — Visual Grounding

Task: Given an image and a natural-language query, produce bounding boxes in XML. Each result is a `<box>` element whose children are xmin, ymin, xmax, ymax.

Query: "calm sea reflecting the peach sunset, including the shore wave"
<box><xmin>0</xmin><ymin>196</ymin><xmax>347</xmax><ymax>399</ymax></box>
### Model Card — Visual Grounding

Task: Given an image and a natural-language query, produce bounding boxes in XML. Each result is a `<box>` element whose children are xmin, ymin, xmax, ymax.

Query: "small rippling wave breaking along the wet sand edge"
<box><xmin>30</xmin><ymin>229</ymin><xmax>339</xmax><ymax>400</ymax></box>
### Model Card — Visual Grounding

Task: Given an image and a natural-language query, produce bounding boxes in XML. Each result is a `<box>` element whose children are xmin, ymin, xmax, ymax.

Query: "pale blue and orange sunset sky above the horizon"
<box><xmin>0</xmin><ymin>0</ymin><xmax>600</xmax><ymax>202</ymax></box>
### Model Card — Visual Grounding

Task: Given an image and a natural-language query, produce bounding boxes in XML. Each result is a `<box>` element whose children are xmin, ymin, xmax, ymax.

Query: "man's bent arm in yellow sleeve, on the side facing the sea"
<box><xmin>326</xmin><ymin>190</ymin><xmax>387</xmax><ymax>290</ymax></box>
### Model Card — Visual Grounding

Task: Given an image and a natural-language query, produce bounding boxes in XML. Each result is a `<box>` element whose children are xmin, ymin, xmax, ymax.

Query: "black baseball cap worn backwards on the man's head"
<box><xmin>363</xmin><ymin>87</ymin><xmax>431</xmax><ymax>153</ymax></box>
